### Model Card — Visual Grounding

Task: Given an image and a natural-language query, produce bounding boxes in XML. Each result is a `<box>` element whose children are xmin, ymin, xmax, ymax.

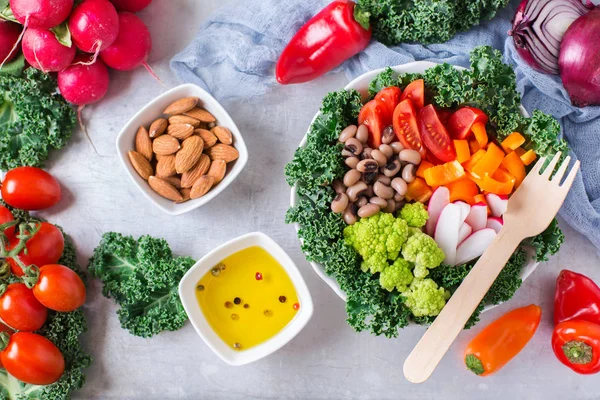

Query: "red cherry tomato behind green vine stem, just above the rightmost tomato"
<box><xmin>8</xmin><ymin>222</ymin><xmax>65</xmax><ymax>276</ymax></box>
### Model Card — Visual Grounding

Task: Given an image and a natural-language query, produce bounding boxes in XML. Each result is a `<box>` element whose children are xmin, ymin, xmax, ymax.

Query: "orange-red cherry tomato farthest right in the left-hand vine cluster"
<box><xmin>33</xmin><ymin>264</ymin><xmax>85</xmax><ymax>312</ymax></box>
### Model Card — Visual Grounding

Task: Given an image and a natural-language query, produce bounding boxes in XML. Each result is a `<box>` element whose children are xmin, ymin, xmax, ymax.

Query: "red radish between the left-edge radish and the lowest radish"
<box><xmin>21</xmin><ymin>28</ymin><xmax>76</xmax><ymax>72</ymax></box>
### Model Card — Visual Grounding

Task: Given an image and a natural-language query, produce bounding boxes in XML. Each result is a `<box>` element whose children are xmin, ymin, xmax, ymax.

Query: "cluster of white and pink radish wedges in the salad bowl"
<box><xmin>425</xmin><ymin>186</ymin><xmax>508</xmax><ymax>265</ymax></box>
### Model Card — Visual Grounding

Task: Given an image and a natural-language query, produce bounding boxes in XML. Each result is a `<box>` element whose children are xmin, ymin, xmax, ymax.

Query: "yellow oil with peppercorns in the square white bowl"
<box><xmin>196</xmin><ymin>246</ymin><xmax>300</xmax><ymax>351</ymax></box>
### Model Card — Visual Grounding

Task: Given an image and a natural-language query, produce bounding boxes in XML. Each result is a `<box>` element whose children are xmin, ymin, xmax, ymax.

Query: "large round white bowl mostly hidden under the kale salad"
<box><xmin>290</xmin><ymin>61</ymin><xmax>539</xmax><ymax>311</ymax></box>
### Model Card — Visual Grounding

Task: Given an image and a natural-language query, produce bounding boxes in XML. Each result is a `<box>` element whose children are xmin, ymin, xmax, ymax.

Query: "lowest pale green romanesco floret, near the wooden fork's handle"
<box><xmin>402</xmin><ymin>278</ymin><xmax>450</xmax><ymax>317</ymax></box>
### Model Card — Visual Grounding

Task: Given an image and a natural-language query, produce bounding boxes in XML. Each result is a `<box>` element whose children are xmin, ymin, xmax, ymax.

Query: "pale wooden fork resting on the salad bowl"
<box><xmin>404</xmin><ymin>153</ymin><xmax>579</xmax><ymax>383</ymax></box>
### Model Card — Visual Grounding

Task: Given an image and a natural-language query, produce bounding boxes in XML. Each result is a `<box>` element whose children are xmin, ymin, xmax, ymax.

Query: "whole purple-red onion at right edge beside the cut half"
<box><xmin>558</xmin><ymin>8</ymin><xmax>600</xmax><ymax>107</ymax></box>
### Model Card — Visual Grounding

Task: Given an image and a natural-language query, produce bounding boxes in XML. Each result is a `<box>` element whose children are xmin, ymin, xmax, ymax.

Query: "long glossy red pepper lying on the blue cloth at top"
<box><xmin>275</xmin><ymin>0</ymin><xmax>371</xmax><ymax>85</ymax></box>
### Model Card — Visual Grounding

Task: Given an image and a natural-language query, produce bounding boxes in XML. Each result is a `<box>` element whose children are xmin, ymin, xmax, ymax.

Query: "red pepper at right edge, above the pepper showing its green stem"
<box><xmin>554</xmin><ymin>269</ymin><xmax>600</xmax><ymax>325</ymax></box>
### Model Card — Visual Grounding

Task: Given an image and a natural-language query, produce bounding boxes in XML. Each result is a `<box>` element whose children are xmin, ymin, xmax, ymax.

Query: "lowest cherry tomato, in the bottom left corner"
<box><xmin>0</xmin><ymin>332</ymin><xmax>65</xmax><ymax>385</ymax></box>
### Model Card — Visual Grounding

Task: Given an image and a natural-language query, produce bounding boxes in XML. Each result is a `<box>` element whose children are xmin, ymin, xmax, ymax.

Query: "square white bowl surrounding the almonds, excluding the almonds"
<box><xmin>117</xmin><ymin>83</ymin><xmax>248</xmax><ymax>215</ymax></box>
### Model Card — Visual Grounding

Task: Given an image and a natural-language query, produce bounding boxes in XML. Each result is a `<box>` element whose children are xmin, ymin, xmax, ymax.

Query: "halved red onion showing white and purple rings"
<box><xmin>508</xmin><ymin>0</ymin><xmax>593</xmax><ymax>74</ymax></box>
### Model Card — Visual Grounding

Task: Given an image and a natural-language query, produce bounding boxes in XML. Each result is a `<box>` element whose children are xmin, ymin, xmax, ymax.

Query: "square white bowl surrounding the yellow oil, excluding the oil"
<box><xmin>179</xmin><ymin>232</ymin><xmax>314</xmax><ymax>365</ymax></box>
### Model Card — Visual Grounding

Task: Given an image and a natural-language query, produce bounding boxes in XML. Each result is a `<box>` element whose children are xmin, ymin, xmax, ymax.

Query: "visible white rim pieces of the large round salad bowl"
<box><xmin>290</xmin><ymin>61</ymin><xmax>540</xmax><ymax>312</ymax></box>
